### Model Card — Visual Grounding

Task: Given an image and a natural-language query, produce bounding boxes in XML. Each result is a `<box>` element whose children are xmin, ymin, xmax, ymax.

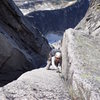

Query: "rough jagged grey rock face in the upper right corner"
<box><xmin>76</xmin><ymin>0</ymin><xmax>100</xmax><ymax>36</ymax></box>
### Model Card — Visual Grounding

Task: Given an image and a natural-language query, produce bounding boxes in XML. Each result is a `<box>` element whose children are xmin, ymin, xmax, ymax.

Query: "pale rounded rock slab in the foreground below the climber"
<box><xmin>0</xmin><ymin>68</ymin><xmax>70</xmax><ymax>100</ymax></box>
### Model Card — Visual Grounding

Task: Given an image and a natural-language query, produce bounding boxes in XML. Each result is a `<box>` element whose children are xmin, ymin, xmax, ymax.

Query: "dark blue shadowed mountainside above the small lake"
<box><xmin>26</xmin><ymin>0</ymin><xmax>89</xmax><ymax>34</ymax></box>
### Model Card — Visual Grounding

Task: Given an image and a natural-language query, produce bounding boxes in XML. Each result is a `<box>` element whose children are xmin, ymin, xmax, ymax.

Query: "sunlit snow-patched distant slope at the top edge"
<box><xmin>14</xmin><ymin>0</ymin><xmax>76</xmax><ymax>14</ymax></box>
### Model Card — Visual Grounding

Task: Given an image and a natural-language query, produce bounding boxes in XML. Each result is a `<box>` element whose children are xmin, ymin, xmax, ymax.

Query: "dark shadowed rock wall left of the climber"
<box><xmin>0</xmin><ymin>0</ymin><xmax>50</xmax><ymax>85</ymax></box>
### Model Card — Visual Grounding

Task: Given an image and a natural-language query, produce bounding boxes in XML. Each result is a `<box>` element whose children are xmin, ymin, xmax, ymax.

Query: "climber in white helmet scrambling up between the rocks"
<box><xmin>46</xmin><ymin>49</ymin><xmax>62</xmax><ymax>72</ymax></box>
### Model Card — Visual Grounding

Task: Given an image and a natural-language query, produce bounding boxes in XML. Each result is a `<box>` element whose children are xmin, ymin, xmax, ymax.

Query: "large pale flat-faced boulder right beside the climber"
<box><xmin>62</xmin><ymin>29</ymin><xmax>100</xmax><ymax>100</ymax></box>
